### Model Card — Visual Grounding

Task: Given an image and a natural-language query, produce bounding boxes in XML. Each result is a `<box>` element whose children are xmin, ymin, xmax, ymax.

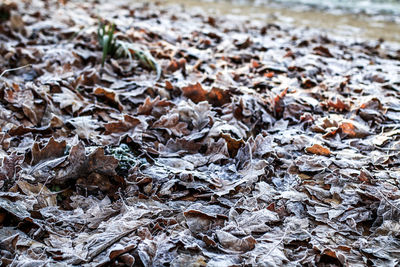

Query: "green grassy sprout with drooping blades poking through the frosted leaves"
<box><xmin>97</xmin><ymin>22</ymin><xmax>161</xmax><ymax>80</ymax></box>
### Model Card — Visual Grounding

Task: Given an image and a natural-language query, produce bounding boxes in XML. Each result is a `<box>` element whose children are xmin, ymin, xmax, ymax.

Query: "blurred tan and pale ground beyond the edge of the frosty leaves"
<box><xmin>145</xmin><ymin>0</ymin><xmax>400</xmax><ymax>44</ymax></box>
